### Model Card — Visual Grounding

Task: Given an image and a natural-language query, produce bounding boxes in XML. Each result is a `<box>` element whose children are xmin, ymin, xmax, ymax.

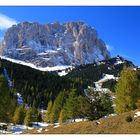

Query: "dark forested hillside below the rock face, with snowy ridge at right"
<box><xmin>0</xmin><ymin>56</ymin><xmax>136</xmax><ymax>109</ymax></box>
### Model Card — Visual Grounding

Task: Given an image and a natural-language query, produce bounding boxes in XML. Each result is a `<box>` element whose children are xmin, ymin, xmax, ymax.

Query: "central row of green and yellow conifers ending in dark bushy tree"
<box><xmin>45</xmin><ymin>89</ymin><xmax>113</xmax><ymax>123</ymax></box>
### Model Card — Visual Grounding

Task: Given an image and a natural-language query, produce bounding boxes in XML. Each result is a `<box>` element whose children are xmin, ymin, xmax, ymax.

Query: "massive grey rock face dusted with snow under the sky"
<box><xmin>1</xmin><ymin>22</ymin><xmax>110</xmax><ymax>67</ymax></box>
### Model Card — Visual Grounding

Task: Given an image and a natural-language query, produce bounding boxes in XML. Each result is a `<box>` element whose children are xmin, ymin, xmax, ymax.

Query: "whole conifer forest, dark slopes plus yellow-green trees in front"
<box><xmin>0</xmin><ymin>55</ymin><xmax>140</xmax><ymax>130</ymax></box>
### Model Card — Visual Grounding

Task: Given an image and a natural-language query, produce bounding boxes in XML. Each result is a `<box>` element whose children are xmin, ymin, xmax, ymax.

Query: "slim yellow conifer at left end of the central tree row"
<box><xmin>45</xmin><ymin>100</ymin><xmax>53</xmax><ymax>122</ymax></box>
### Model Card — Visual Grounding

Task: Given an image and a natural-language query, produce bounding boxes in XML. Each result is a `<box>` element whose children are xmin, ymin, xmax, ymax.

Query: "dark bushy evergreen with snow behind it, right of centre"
<box><xmin>85</xmin><ymin>87</ymin><xmax>114</xmax><ymax>120</ymax></box>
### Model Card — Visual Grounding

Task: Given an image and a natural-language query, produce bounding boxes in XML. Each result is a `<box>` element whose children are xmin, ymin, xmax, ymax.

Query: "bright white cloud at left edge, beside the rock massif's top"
<box><xmin>0</xmin><ymin>13</ymin><xmax>17</xmax><ymax>30</ymax></box>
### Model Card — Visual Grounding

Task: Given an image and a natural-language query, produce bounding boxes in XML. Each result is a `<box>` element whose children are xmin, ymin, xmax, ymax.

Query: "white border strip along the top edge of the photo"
<box><xmin>0</xmin><ymin>0</ymin><xmax>140</xmax><ymax>6</ymax></box>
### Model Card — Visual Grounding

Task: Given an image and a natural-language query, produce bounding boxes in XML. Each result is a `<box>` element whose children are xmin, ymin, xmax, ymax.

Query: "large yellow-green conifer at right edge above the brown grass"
<box><xmin>115</xmin><ymin>67</ymin><xmax>140</xmax><ymax>113</ymax></box>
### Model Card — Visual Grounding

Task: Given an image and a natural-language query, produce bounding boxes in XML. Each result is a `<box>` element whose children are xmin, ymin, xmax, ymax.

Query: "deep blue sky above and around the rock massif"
<box><xmin>0</xmin><ymin>6</ymin><xmax>140</xmax><ymax>65</ymax></box>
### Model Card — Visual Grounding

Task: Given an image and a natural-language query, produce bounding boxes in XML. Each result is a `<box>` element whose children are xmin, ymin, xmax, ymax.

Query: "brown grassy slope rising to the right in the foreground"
<box><xmin>24</xmin><ymin>111</ymin><xmax>140</xmax><ymax>134</ymax></box>
